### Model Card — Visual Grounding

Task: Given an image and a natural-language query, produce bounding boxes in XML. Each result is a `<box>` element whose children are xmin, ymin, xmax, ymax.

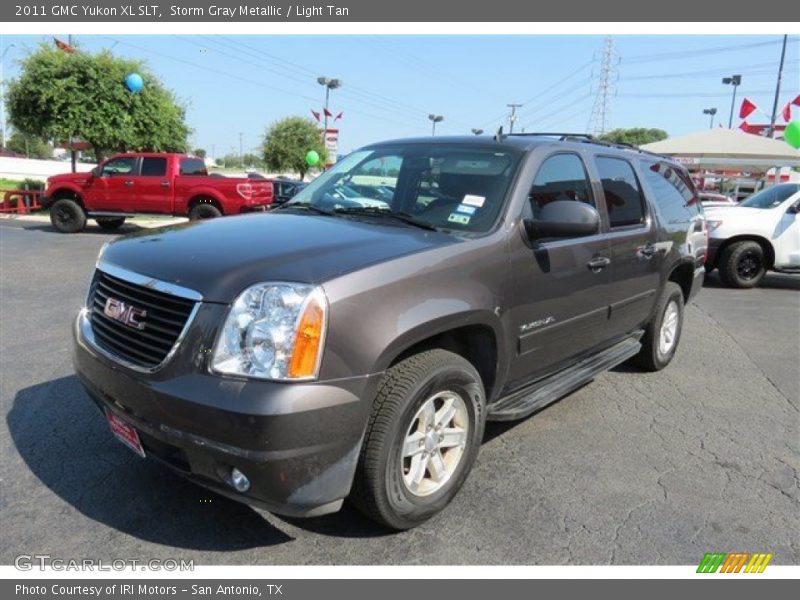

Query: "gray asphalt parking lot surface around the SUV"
<box><xmin>0</xmin><ymin>221</ymin><xmax>800</xmax><ymax>565</ymax></box>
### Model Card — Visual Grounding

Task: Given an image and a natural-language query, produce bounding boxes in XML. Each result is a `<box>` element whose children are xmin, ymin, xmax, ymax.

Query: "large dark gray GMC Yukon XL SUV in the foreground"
<box><xmin>75</xmin><ymin>132</ymin><xmax>707</xmax><ymax>529</ymax></box>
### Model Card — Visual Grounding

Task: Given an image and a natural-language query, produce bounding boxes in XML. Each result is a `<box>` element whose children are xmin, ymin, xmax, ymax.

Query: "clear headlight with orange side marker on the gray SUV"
<box><xmin>211</xmin><ymin>283</ymin><xmax>328</xmax><ymax>381</ymax></box>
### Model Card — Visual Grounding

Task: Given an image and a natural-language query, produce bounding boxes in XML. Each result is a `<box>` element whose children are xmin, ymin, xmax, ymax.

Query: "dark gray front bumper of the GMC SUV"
<box><xmin>74</xmin><ymin>310</ymin><xmax>380</xmax><ymax>516</ymax></box>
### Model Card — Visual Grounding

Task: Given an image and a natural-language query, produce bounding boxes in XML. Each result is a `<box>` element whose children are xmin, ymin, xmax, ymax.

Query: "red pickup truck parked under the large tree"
<box><xmin>42</xmin><ymin>152</ymin><xmax>272</xmax><ymax>233</ymax></box>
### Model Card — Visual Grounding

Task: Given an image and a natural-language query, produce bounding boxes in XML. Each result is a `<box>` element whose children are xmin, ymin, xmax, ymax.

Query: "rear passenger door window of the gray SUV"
<box><xmin>596</xmin><ymin>156</ymin><xmax>645</xmax><ymax>227</ymax></box>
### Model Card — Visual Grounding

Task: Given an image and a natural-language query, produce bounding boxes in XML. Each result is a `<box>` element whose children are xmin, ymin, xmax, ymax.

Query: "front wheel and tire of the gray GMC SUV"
<box><xmin>350</xmin><ymin>349</ymin><xmax>486</xmax><ymax>530</ymax></box>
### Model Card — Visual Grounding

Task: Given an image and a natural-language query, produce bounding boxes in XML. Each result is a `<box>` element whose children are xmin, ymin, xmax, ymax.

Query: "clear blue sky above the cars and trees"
<box><xmin>0</xmin><ymin>33</ymin><xmax>800</xmax><ymax>156</ymax></box>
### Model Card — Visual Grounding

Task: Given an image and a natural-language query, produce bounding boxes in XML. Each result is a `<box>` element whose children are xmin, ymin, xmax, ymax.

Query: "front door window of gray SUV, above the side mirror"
<box><xmin>529</xmin><ymin>154</ymin><xmax>593</xmax><ymax>218</ymax></box>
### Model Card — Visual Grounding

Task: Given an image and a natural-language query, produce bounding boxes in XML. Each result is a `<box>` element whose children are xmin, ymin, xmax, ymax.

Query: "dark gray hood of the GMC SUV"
<box><xmin>102</xmin><ymin>213</ymin><xmax>459</xmax><ymax>303</ymax></box>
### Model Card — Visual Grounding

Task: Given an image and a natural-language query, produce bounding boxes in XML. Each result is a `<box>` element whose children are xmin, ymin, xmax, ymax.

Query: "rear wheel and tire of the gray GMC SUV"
<box><xmin>631</xmin><ymin>281</ymin><xmax>683</xmax><ymax>371</ymax></box>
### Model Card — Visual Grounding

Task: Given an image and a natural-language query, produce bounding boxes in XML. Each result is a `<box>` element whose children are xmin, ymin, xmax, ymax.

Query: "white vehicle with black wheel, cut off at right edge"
<box><xmin>705</xmin><ymin>183</ymin><xmax>800</xmax><ymax>288</ymax></box>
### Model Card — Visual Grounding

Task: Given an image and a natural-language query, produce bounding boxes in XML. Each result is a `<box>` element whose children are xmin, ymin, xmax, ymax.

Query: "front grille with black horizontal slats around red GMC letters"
<box><xmin>89</xmin><ymin>270</ymin><xmax>195</xmax><ymax>369</ymax></box>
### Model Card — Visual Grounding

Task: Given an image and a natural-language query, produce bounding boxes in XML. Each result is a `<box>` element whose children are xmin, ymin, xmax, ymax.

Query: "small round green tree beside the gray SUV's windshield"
<box><xmin>264</xmin><ymin>117</ymin><xmax>327</xmax><ymax>178</ymax></box>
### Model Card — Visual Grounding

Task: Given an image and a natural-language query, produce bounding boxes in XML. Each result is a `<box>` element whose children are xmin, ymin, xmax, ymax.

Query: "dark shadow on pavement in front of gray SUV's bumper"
<box><xmin>7</xmin><ymin>376</ymin><xmax>293</xmax><ymax>551</ymax></box>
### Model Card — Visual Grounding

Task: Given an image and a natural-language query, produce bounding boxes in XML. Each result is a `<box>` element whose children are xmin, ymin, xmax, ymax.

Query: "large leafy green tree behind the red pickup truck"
<box><xmin>7</xmin><ymin>44</ymin><xmax>190</xmax><ymax>160</ymax></box>
